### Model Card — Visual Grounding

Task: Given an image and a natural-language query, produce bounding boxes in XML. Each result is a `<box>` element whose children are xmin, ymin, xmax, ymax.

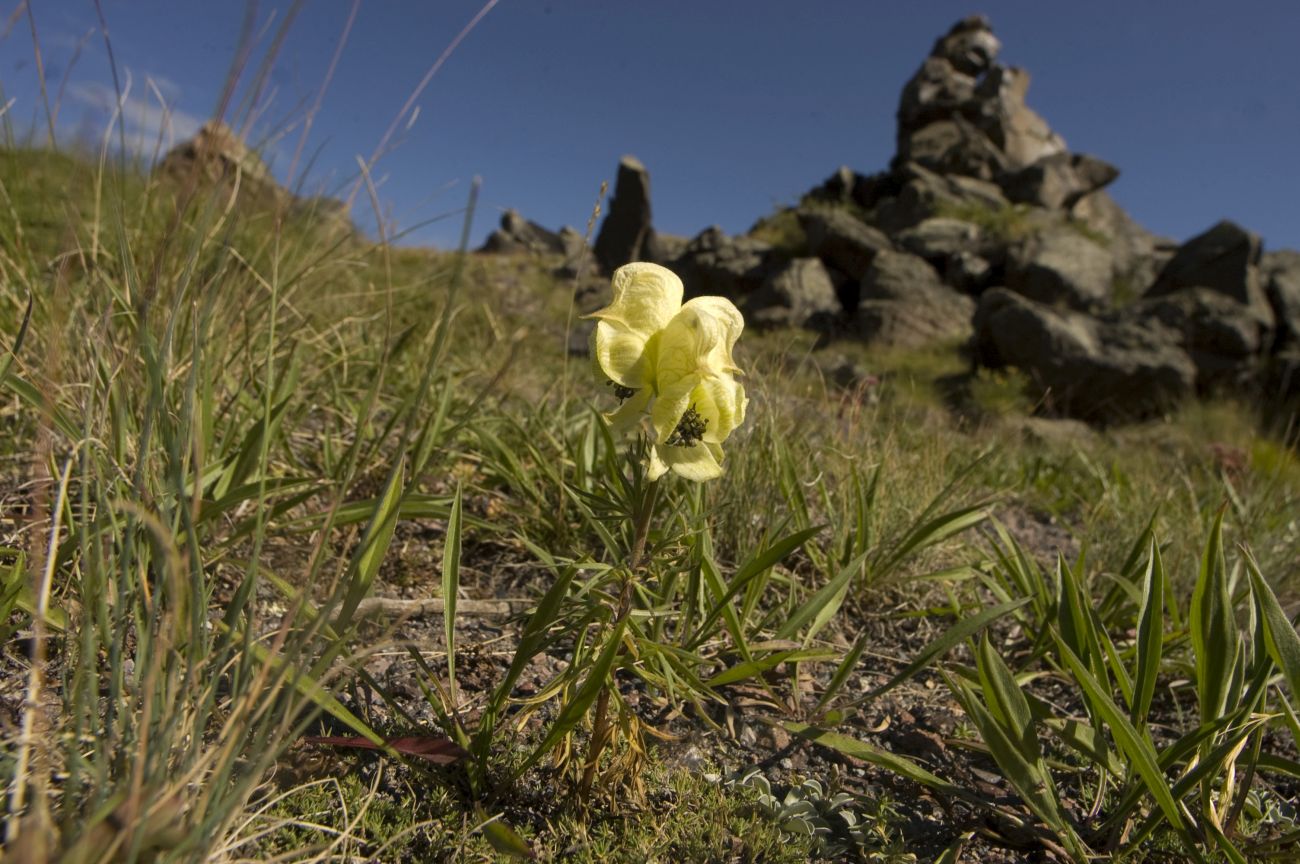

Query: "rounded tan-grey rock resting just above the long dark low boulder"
<box><xmin>1006</xmin><ymin>226</ymin><xmax>1114</xmax><ymax>309</ymax></box>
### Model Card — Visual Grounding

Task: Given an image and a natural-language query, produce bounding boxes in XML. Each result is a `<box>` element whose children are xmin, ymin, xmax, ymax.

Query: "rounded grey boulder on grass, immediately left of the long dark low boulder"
<box><xmin>853</xmin><ymin>249</ymin><xmax>975</xmax><ymax>347</ymax></box>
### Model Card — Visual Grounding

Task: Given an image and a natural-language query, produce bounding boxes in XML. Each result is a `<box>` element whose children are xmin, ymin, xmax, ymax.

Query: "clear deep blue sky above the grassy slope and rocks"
<box><xmin>0</xmin><ymin>0</ymin><xmax>1300</xmax><ymax>248</ymax></box>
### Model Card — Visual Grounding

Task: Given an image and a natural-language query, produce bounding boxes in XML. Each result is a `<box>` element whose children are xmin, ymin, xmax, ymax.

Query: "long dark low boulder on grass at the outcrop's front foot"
<box><xmin>972</xmin><ymin>288</ymin><xmax>1196</xmax><ymax>422</ymax></box>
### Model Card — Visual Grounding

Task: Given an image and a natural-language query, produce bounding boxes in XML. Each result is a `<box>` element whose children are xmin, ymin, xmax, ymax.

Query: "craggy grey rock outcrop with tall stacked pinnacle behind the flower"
<box><xmin>482</xmin><ymin>17</ymin><xmax>1300</xmax><ymax>422</ymax></box>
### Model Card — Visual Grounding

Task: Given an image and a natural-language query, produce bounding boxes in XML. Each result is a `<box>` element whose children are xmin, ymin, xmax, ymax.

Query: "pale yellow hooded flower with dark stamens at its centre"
<box><xmin>589</xmin><ymin>262</ymin><xmax>749</xmax><ymax>481</ymax></box>
